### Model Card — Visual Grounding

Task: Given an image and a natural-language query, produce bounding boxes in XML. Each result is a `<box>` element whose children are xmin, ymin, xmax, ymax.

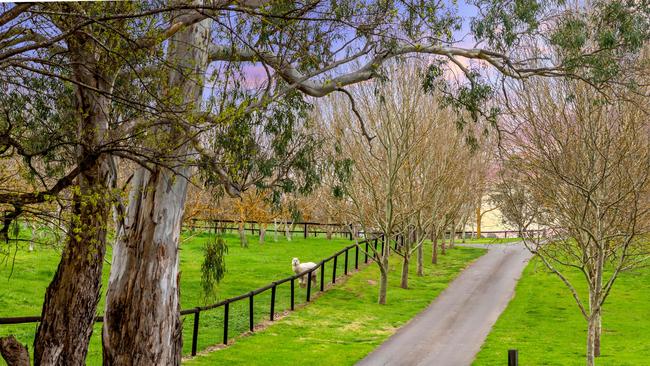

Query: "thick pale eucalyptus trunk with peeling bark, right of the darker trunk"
<box><xmin>102</xmin><ymin>8</ymin><xmax>210</xmax><ymax>365</ymax></box>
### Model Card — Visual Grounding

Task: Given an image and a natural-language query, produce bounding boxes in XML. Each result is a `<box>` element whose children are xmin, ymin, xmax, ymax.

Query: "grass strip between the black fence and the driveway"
<box><xmin>184</xmin><ymin>245</ymin><xmax>485</xmax><ymax>366</ymax></box>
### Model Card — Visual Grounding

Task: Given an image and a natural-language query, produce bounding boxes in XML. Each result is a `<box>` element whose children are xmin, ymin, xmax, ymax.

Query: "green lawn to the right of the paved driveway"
<box><xmin>474</xmin><ymin>259</ymin><xmax>650</xmax><ymax>366</ymax></box>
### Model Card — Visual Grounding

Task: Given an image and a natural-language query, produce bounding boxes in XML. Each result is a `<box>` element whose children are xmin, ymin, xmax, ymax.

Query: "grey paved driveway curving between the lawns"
<box><xmin>357</xmin><ymin>244</ymin><xmax>532</xmax><ymax>366</ymax></box>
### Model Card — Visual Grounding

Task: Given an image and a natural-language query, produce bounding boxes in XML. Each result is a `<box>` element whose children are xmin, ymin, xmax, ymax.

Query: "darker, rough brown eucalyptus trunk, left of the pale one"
<box><xmin>34</xmin><ymin>37</ymin><xmax>115</xmax><ymax>365</ymax></box>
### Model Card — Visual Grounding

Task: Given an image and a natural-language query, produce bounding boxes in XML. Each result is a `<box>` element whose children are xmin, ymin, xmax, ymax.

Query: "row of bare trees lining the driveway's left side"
<box><xmin>319</xmin><ymin>61</ymin><xmax>490</xmax><ymax>304</ymax></box>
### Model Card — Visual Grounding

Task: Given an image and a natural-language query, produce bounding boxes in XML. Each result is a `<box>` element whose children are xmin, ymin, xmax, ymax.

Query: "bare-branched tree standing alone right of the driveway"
<box><xmin>494</xmin><ymin>80</ymin><xmax>650</xmax><ymax>365</ymax></box>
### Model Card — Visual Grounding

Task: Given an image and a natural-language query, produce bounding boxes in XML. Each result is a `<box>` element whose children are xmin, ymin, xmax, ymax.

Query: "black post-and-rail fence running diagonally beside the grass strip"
<box><xmin>0</xmin><ymin>235</ymin><xmax>384</xmax><ymax>356</ymax></box>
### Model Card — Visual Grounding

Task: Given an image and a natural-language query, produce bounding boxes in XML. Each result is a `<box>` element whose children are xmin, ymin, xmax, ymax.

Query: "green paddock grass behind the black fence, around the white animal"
<box><xmin>0</xmin><ymin>232</ymin><xmax>354</xmax><ymax>365</ymax></box>
